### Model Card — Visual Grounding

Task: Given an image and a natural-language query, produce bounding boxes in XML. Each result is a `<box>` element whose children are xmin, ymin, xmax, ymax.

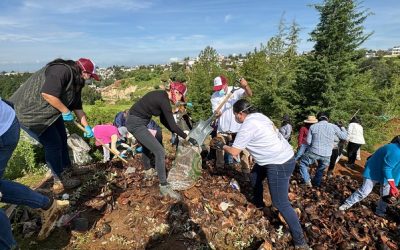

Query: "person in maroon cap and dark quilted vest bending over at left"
<box><xmin>10</xmin><ymin>58</ymin><xmax>100</xmax><ymax>193</ymax></box>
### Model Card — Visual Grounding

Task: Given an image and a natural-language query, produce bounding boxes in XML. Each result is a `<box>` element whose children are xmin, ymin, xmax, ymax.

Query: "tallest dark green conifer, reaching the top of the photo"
<box><xmin>297</xmin><ymin>0</ymin><xmax>372</xmax><ymax>117</ymax></box>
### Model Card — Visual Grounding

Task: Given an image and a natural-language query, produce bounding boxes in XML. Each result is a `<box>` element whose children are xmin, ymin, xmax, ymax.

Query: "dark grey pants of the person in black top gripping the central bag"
<box><xmin>126</xmin><ymin>115</ymin><xmax>167</xmax><ymax>185</ymax></box>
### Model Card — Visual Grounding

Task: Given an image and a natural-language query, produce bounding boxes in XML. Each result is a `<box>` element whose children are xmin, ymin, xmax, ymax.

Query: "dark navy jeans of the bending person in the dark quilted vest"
<box><xmin>21</xmin><ymin>116</ymin><xmax>71</xmax><ymax>177</ymax></box>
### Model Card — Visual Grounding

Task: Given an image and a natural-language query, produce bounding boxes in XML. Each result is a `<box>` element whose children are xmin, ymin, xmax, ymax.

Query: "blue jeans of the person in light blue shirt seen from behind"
<box><xmin>300</xmin><ymin>152</ymin><xmax>331</xmax><ymax>187</ymax></box>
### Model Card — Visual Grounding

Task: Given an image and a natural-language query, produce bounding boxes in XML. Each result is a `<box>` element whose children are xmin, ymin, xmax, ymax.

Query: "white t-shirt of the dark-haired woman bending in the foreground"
<box><xmin>232</xmin><ymin>113</ymin><xmax>294</xmax><ymax>166</ymax></box>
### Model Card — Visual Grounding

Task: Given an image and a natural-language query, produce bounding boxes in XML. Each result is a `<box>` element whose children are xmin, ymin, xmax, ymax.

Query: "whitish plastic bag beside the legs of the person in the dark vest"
<box><xmin>67</xmin><ymin>134</ymin><xmax>93</xmax><ymax>165</ymax></box>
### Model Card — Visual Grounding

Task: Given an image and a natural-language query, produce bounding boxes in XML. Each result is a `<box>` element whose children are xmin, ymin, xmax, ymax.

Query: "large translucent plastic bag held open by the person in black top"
<box><xmin>167</xmin><ymin>140</ymin><xmax>202</xmax><ymax>190</ymax></box>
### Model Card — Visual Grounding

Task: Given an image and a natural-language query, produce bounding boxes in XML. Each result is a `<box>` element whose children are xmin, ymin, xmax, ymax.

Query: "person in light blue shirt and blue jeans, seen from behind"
<box><xmin>300</xmin><ymin>112</ymin><xmax>347</xmax><ymax>187</ymax></box>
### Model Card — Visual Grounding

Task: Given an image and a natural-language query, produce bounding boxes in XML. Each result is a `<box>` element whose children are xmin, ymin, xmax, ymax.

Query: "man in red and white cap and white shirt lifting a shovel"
<box><xmin>211</xmin><ymin>75</ymin><xmax>253</xmax><ymax>169</ymax></box>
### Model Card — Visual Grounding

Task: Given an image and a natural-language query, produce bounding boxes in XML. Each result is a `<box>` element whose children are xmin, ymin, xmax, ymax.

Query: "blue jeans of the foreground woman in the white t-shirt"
<box><xmin>250</xmin><ymin>158</ymin><xmax>305</xmax><ymax>246</ymax></box>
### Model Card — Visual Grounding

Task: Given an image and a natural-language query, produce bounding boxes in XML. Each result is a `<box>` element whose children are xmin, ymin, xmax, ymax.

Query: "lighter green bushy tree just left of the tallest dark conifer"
<box><xmin>241</xmin><ymin>18</ymin><xmax>300</xmax><ymax>120</ymax></box>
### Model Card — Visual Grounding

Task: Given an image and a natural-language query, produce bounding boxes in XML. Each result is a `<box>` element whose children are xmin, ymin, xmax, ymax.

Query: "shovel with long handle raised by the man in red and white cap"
<box><xmin>187</xmin><ymin>80</ymin><xmax>239</xmax><ymax>145</ymax></box>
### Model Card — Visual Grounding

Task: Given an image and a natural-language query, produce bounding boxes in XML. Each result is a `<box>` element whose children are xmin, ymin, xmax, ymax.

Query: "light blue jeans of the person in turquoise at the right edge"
<box><xmin>344</xmin><ymin>178</ymin><xmax>390</xmax><ymax>215</ymax></box>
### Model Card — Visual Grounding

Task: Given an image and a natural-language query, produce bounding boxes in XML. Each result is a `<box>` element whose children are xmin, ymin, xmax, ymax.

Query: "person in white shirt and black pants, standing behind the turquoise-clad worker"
<box><xmin>347</xmin><ymin>116</ymin><xmax>365</xmax><ymax>168</ymax></box>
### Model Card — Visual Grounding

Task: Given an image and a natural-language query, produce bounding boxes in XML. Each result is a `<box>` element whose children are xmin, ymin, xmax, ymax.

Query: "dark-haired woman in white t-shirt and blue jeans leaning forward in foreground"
<box><xmin>212</xmin><ymin>99</ymin><xmax>308</xmax><ymax>249</ymax></box>
